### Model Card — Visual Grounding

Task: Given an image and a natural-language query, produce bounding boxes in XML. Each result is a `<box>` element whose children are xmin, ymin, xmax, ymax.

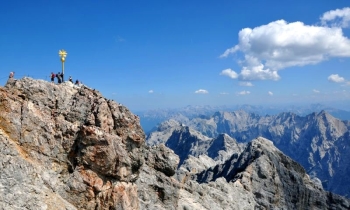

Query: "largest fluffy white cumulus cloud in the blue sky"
<box><xmin>220</xmin><ymin>8</ymin><xmax>350</xmax><ymax>80</ymax></box>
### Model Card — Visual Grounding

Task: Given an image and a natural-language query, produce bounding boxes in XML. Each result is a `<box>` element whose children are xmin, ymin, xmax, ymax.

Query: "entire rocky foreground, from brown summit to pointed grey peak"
<box><xmin>0</xmin><ymin>78</ymin><xmax>350</xmax><ymax>210</ymax></box>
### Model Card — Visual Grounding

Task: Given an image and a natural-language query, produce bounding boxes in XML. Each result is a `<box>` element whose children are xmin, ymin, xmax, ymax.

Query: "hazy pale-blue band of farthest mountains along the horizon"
<box><xmin>135</xmin><ymin>104</ymin><xmax>350</xmax><ymax>134</ymax></box>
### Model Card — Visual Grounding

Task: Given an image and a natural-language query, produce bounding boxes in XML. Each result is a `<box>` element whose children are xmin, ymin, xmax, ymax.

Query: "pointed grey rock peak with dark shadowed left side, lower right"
<box><xmin>197</xmin><ymin>137</ymin><xmax>350</xmax><ymax>209</ymax></box>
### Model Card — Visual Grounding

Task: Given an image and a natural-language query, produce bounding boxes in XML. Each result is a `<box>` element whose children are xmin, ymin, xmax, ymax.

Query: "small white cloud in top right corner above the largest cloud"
<box><xmin>320</xmin><ymin>7</ymin><xmax>350</xmax><ymax>28</ymax></box>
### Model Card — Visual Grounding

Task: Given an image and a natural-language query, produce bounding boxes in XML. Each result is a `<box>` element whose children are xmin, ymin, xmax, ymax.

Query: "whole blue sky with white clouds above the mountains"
<box><xmin>0</xmin><ymin>0</ymin><xmax>350</xmax><ymax>111</ymax></box>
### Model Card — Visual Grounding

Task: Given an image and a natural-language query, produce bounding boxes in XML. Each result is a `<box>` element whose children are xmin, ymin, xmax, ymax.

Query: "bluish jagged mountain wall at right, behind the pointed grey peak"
<box><xmin>150</xmin><ymin>110</ymin><xmax>350</xmax><ymax>197</ymax></box>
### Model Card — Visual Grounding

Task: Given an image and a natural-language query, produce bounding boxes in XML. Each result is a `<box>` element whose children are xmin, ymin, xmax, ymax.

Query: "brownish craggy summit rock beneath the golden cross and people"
<box><xmin>0</xmin><ymin>77</ymin><xmax>145</xmax><ymax>209</ymax></box>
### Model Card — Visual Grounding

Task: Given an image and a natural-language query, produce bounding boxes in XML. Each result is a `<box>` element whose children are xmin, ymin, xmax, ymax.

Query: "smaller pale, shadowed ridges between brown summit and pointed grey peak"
<box><xmin>147</xmin><ymin>123</ymin><xmax>244</xmax><ymax>182</ymax></box>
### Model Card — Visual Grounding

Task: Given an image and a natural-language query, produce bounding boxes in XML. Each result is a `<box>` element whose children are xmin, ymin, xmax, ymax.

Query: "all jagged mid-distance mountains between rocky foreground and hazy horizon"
<box><xmin>147</xmin><ymin>110</ymin><xmax>350</xmax><ymax>197</ymax></box>
